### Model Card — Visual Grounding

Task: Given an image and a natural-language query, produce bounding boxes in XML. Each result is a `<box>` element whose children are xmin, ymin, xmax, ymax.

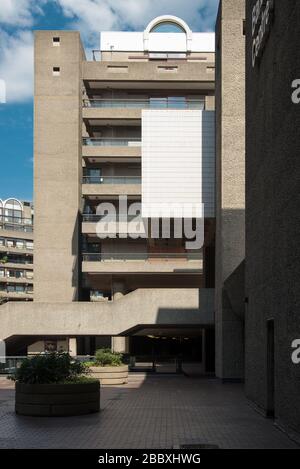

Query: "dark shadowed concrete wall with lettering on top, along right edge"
<box><xmin>245</xmin><ymin>0</ymin><xmax>300</xmax><ymax>432</ymax></box>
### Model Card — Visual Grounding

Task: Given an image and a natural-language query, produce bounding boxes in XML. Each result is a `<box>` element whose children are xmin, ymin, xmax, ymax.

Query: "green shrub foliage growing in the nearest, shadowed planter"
<box><xmin>9</xmin><ymin>352</ymin><xmax>88</xmax><ymax>384</ymax></box>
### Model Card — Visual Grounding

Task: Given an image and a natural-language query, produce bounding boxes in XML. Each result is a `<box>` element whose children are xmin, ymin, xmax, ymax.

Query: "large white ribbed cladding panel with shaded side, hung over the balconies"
<box><xmin>142</xmin><ymin>110</ymin><xmax>215</xmax><ymax>217</ymax></box>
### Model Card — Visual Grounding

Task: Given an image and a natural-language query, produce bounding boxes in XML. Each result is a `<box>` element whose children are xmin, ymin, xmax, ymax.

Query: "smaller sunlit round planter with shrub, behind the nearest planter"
<box><xmin>87</xmin><ymin>349</ymin><xmax>128</xmax><ymax>385</ymax></box>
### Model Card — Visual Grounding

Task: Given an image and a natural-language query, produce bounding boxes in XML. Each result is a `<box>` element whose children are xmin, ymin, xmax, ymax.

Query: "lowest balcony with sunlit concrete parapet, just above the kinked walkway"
<box><xmin>82</xmin><ymin>252</ymin><xmax>203</xmax><ymax>275</ymax></box>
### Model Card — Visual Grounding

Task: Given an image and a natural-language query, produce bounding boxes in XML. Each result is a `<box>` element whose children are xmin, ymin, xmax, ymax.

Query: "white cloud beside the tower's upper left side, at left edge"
<box><xmin>0</xmin><ymin>31</ymin><xmax>33</xmax><ymax>103</ymax></box>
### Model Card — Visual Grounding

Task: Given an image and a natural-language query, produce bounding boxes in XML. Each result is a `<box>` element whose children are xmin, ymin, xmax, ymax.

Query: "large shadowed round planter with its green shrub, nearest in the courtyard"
<box><xmin>10</xmin><ymin>353</ymin><xmax>100</xmax><ymax>416</ymax></box>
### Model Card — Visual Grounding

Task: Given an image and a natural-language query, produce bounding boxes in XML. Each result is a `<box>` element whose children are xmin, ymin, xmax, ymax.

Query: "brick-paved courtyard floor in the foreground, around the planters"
<box><xmin>0</xmin><ymin>374</ymin><xmax>298</xmax><ymax>449</ymax></box>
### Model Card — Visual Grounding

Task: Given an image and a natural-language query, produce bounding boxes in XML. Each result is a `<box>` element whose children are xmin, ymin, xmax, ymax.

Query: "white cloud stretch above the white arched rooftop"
<box><xmin>56</xmin><ymin>0</ymin><xmax>219</xmax><ymax>38</ymax></box>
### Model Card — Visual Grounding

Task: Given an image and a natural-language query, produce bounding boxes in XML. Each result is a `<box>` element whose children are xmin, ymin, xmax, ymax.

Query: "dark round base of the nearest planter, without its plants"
<box><xmin>15</xmin><ymin>382</ymin><xmax>100</xmax><ymax>417</ymax></box>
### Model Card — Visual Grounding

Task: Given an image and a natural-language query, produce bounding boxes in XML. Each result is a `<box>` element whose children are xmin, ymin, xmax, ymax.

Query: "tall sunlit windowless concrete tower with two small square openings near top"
<box><xmin>34</xmin><ymin>31</ymin><xmax>84</xmax><ymax>302</ymax></box>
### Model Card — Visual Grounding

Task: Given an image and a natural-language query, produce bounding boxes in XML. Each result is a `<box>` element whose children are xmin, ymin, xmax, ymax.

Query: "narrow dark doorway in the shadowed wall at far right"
<box><xmin>266</xmin><ymin>319</ymin><xmax>275</xmax><ymax>418</ymax></box>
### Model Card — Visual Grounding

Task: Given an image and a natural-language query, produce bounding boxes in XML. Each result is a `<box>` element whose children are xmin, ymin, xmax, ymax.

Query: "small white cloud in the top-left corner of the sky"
<box><xmin>0</xmin><ymin>0</ymin><xmax>45</xmax><ymax>27</ymax></box>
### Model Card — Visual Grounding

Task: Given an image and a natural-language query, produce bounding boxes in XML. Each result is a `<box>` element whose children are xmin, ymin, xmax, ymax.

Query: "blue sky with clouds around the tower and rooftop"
<box><xmin>0</xmin><ymin>0</ymin><xmax>219</xmax><ymax>200</ymax></box>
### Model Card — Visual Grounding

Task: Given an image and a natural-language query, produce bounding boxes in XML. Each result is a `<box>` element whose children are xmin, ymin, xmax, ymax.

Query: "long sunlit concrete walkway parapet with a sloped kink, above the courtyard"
<box><xmin>0</xmin><ymin>289</ymin><xmax>214</xmax><ymax>340</ymax></box>
